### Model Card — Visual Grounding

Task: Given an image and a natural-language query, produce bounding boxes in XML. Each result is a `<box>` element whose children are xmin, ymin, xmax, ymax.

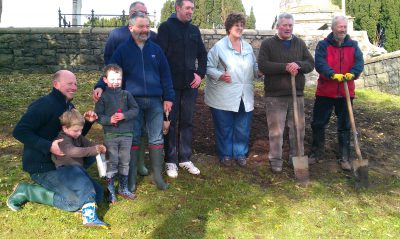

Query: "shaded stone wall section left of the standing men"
<box><xmin>0</xmin><ymin>28</ymin><xmax>111</xmax><ymax>73</ymax></box>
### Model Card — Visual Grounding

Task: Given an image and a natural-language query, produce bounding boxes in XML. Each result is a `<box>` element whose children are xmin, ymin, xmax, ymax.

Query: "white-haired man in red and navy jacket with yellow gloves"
<box><xmin>309</xmin><ymin>16</ymin><xmax>364</xmax><ymax>170</ymax></box>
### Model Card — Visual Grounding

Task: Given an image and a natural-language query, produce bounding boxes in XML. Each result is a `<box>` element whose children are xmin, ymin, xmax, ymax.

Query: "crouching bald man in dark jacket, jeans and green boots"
<box><xmin>7</xmin><ymin>70</ymin><xmax>108</xmax><ymax>228</ymax></box>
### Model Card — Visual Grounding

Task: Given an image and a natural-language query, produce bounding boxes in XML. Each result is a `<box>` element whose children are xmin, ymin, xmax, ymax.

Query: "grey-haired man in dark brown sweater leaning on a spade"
<box><xmin>258</xmin><ymin>13</ymin><xmax>314</xmax><ymax>172</ymax></box>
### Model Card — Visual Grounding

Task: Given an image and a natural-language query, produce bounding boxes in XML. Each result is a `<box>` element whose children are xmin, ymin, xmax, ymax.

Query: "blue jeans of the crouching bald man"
<box><xmin>31</xmin><ymin>165</ymin><xmax>103</xmax><ymax>212</ymax></box>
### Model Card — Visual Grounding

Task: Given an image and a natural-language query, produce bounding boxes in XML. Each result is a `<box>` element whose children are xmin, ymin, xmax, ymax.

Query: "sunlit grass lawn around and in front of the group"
<box><xmin>0</xmin><ymin>73</ymin><xmax>400</xmax><ymax>239</ymax></box>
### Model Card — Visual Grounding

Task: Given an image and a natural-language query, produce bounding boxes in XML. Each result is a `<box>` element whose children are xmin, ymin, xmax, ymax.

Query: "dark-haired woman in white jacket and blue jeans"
<box><xmin>204</xmin><ymin>13</ymin><xmax>257</xmax><ymax>167</ymax></box>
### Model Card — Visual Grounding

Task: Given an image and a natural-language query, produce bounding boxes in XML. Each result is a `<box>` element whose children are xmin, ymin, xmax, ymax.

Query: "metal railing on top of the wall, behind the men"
<box><xmin>58</xmin><ymin>9</ymin><xmax>156</xmax><ymax>28</ymax></box>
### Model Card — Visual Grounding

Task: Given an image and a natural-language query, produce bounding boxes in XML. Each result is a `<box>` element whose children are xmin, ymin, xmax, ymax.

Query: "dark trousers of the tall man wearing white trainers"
<box><xmin>165</xmin><ymin>88</ymin><xmax>198</xmax><ymax>164</ymax></box>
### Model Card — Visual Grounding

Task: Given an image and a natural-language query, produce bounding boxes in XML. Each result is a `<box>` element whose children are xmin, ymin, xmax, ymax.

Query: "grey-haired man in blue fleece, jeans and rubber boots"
<box><xmin>110</xmin><ymin>12</ymin><xmax>175</xmax><ymax>190</ymax></box>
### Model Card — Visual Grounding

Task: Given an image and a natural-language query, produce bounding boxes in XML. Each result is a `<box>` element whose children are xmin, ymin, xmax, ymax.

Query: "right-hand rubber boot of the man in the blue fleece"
<box><xmin>149</xmin><ymin>148</ymin><xmax>169</xmax><ymax>190</ymax></box>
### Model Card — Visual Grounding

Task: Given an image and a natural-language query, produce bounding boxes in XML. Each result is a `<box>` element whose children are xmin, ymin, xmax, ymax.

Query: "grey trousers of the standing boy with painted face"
<box><xmin>104</xmin><ymin>136</ymin><xmax>132</xmax><ymax>178</ymax></box>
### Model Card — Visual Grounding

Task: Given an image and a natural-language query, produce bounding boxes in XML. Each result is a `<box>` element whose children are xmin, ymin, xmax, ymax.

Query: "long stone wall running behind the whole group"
<box><xmin>0</xmin><ymin>28</ymin><xmax>399</xmax><ymax>94</ymax></box>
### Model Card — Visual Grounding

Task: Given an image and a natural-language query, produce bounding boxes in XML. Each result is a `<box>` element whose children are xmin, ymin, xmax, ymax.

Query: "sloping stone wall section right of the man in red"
<box><xmin>358</xmin><ymin>51</ymin><xmax>400</xmax><ymax>95</ymax></box>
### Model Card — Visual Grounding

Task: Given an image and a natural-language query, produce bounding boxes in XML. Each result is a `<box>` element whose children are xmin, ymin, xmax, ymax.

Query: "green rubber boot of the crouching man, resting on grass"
<box><xmin>7</xmin><ymin>183</ymin><xmax>54</xmax><ymax>211</ymax></box>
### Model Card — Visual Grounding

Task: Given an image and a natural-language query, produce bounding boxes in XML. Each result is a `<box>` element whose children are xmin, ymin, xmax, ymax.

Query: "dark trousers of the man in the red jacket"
<box><xmin>311</xmin><ymin>96</ymin><xmax>353</xmax><ymax>133</ymax></box>
